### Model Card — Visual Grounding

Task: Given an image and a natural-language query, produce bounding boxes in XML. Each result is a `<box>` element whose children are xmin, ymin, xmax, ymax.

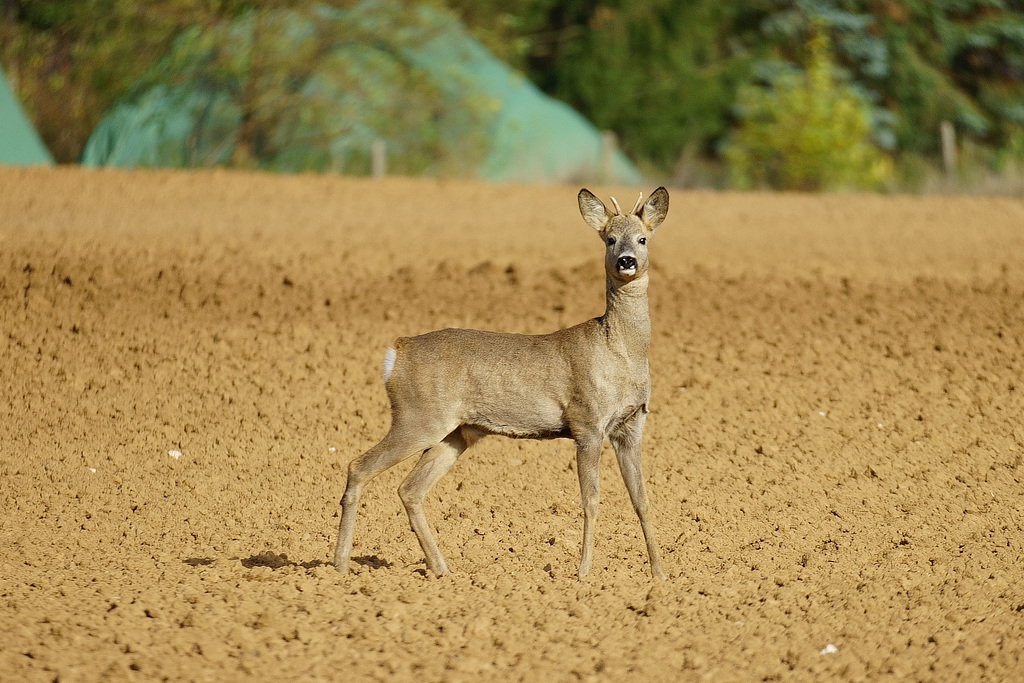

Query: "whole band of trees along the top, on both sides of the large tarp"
<box><xmin>0</xmin><ymin>0</ymin><xmax>1024</xmax><ymax>181</ymax></box>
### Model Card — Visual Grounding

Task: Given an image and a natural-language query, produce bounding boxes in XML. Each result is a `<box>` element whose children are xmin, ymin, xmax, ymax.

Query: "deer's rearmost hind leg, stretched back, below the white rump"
<box><xmin>334</xmin><ymin>421</ymin><xmax>444</xmax><ymax>573</ymax></box>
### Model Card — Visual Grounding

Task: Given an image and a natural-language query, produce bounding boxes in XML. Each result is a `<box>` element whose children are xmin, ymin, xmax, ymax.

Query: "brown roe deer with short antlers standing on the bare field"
<box><xmin>335</xmin><ymin>187</ymin><xmax>669</xmax><ymax>581</ymax></box>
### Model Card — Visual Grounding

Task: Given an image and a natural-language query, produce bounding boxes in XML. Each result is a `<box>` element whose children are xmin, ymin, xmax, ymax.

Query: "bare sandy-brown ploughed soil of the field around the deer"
<box><xmin>0</xmin><ymin>168</ymin><xmax>1024</xmax><ymax>682</ymax></box>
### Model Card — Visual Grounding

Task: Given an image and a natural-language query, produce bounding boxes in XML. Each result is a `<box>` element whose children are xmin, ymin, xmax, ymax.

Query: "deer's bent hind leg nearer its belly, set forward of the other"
<box><xmin>398</xmin><ymin>427</ymin><xmax>477</xmax><ymax>577</ymax></box>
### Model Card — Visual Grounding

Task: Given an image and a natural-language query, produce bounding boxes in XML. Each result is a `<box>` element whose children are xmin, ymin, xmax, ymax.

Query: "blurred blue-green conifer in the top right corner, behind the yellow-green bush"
<box><xmin>745</xmin><ymin>0</ymin><xmax>1024</xmax><ymax>154</ymax></box>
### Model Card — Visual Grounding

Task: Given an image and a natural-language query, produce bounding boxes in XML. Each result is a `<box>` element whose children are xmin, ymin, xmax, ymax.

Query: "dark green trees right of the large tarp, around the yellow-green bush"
<box><xmin>450</xmin><ymin>0</ymin><xmax>1024</xmax><ymax>176</ymax></box>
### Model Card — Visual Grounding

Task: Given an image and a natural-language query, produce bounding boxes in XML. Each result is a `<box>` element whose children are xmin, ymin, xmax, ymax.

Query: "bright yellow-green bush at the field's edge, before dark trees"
<box><xmin>725</xmin><ymin>31</ymin><xmax>892</xmax><ymax>190</ymax></box>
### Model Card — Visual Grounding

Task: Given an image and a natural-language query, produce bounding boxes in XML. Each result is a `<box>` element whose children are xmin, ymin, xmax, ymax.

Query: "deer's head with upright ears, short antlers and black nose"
<box><xmin>579</xmin><ymin>187</ymin><xmax>669</xmax><ymax>283</ymax></box>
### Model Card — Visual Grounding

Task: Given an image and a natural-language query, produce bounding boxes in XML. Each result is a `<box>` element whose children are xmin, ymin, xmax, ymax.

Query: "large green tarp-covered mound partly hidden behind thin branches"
<box><xmin>82</xmin><ymin>0</ymin><xmax>641</xmax><ymax>184</ymax></box>
